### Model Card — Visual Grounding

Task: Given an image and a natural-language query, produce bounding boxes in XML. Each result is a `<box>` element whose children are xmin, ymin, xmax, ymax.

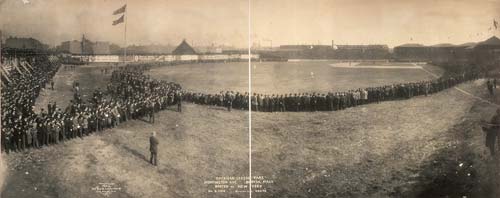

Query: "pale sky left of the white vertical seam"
<box><xmin>0</xmin><ymin>0</ymin><xmax>248</xmax><ymax>46</ymax></box>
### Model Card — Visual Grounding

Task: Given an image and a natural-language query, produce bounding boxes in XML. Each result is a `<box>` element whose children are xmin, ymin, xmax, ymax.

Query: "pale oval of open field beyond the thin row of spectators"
<box><xmin>148</xmin><ymin>61</ymin><xmax>443</xmax><ymax>94</ymax></box>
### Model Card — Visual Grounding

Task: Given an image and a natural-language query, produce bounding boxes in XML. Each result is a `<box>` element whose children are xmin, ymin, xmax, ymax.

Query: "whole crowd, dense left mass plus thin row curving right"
<box><xmin>1</xmin><ymin>56</ymin><xmax>480</xmax><ymax>152</ymax></box>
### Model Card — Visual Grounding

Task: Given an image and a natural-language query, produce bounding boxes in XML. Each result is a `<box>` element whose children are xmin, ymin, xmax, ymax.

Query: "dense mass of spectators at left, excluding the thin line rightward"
<box><xmin>1</xmin><ymin>58</ymin><xmax>181</xmax><ymax>152</ymax></box>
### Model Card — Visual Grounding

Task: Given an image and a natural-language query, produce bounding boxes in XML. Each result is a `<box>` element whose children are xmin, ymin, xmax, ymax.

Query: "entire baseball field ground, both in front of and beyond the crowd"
<box><xmin>1</xmin><ymin>62</ymin><xmax>500</xmax><ymax>197</ymax></box>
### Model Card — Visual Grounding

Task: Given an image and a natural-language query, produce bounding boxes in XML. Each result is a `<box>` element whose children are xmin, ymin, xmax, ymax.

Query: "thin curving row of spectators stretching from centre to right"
<box><xmin>184</xmin><ymin>73</ymin><xmax>479</xmax><ymax>112</ymax></box>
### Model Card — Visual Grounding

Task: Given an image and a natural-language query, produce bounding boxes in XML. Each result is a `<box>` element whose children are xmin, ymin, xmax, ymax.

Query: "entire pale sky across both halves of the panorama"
<box><xmin>0</xmin><ymin>0</ymin><xmax>500</xmax><ymax>47</ymax></box>
